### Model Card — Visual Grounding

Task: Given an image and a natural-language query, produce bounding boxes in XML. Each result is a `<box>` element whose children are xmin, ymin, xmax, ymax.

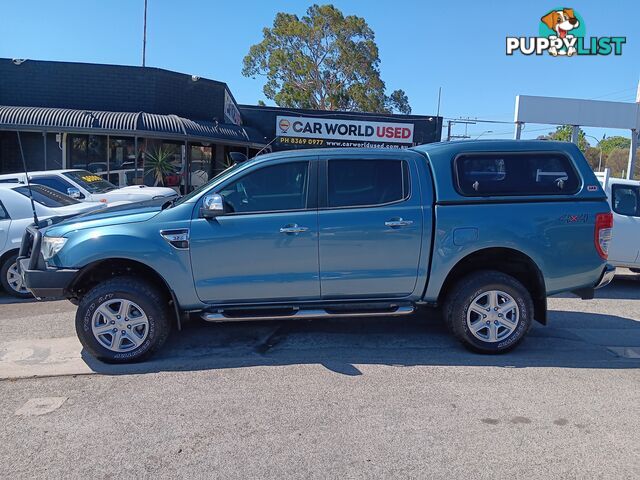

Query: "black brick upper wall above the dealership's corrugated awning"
<box><xmin>0</xmin><ymin>59</ymin><xmax>230</xmax><ymax>123</ymax></box>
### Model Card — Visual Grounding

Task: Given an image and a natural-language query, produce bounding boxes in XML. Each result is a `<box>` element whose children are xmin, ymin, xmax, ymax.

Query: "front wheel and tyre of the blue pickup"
<box><xmin>76</xmin><ymin>277</ymin><xmax>171</xmax><ymax>363</ymax></box>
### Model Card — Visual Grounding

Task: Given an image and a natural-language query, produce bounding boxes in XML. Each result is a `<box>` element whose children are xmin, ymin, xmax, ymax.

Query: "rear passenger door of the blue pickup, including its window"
<box><xmin>318</xmin><ymin>155</ymin><xmax>423</xmax><ymax>299</ymax></box>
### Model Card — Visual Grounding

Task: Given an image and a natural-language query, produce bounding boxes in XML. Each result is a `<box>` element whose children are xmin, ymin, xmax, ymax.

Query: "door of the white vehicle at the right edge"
<box><xmin>609</xmin><ymin>183</ymin><xmax>640</xmax><ymax>265</ymax></box>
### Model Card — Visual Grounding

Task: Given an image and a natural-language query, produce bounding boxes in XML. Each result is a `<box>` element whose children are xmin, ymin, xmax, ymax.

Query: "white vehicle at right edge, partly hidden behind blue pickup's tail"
<box><xmin>596</xmin><ymin>168</ymin><xmax>640</xmax><ymax>273</ymax></box>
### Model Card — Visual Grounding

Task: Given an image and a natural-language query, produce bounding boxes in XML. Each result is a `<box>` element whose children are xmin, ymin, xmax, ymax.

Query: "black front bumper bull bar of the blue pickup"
<box><xmin>17</xmin><ymin>225</ymin><xmax>79</xmax><ymax>298</ymax></box>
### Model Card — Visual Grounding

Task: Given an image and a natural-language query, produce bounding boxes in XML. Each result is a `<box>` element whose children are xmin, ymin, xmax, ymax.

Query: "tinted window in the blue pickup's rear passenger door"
<box><xmin>327</xmin><ymin>160</ymin><xmax>410</xmax><ymax>208</ymax></box>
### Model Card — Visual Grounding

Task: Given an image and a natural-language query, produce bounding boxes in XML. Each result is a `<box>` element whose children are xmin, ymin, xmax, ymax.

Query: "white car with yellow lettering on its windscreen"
<box><xmin>0</xmin><ymin>170</ymin><xmax>178</xmax><ymax>203</ymax></box>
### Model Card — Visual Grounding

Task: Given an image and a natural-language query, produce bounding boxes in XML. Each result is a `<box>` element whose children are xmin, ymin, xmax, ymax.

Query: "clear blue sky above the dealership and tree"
<box><xmin>0</xmin><ymin>0</ymin><xmax>640</xmax><ymax>145</ymax></box>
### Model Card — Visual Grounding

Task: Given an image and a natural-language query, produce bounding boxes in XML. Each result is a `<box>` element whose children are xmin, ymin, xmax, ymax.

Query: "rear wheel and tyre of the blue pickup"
<box><xmin>444</xmin><ymin>270</ymin><xmax>533</xmax><ymax>353</ymax></box>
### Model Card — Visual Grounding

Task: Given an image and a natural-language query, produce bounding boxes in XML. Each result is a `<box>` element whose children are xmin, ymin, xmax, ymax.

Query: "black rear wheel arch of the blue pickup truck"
<box><xmin>438</xmin><ymin>247</ymin><xmax>547</xmax><ymax>325</ymax></box>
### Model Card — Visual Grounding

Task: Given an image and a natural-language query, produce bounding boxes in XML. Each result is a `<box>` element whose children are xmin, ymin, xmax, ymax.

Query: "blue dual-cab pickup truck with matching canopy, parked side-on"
<box><xmin>19</xmin><ymin>140</ymin><xmax>614</xmax><ymax>363</ymax></box>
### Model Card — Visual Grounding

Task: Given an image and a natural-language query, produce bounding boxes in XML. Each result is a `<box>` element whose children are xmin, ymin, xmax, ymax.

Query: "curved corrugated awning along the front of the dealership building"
<box><xmin>0</xmin><ymin>105</ymin><xmax>266</xmax><ymax>148</ymax></box>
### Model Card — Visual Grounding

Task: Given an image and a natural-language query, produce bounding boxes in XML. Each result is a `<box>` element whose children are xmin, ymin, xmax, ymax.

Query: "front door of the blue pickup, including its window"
<box><xmin>191</xmin><ymin>160</ymin><xmax>320</xmax><ymax>304</ymax></box>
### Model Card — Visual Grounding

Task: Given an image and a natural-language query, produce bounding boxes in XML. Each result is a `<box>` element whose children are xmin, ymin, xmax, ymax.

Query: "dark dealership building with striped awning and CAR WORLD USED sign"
<box><xmin>0</xmin><ymin>59</ymin><xmax>442</xmax><ymax>191</ymax></box>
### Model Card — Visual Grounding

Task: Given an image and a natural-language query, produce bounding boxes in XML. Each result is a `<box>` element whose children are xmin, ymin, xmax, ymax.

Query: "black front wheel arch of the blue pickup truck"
<box><xmin>67</xmin><ymin>258</ymin><xmax>181</xmax><ymax>329</ymax></box>
